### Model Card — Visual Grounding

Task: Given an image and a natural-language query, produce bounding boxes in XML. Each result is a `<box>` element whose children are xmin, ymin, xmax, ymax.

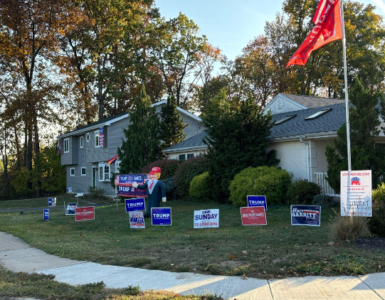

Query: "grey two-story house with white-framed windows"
<box><xmin>58</xmin><ymin>100</ymin><xmax>204</xmax><ymax>195</ymax></box>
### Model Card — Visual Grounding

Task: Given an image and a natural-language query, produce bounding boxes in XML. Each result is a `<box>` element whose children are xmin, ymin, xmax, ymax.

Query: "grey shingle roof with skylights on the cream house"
<box><xmin>163</xmin><ymin>103</ymin><xmax>345</xmax><ymax>153</ymax></box>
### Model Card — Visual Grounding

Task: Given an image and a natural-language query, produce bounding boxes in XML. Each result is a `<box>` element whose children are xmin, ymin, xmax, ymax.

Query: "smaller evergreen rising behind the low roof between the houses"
<box><xmin>160</xmin><ymin>96</ymin><xmax>188</xmax><ymax>149</ymax></box>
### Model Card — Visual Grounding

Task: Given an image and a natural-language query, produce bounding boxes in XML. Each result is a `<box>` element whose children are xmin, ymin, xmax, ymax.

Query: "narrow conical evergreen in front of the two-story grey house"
<box><xmin>118</xmin><ymin>86</ymin><xmax>162</xmax><ymax>174</ymax></box>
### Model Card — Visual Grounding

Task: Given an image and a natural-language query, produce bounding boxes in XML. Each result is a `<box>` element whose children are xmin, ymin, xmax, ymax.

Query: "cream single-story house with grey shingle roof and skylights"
<box><xmin>163</xmin><ymin>94</ymin><xmax>385</xmax><ymax>195</ymax></box>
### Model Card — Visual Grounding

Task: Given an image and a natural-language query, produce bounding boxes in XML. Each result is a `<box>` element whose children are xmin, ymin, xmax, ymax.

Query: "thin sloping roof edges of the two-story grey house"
<box><xmin>59</xmin><ymin>100</ymin><xmax>202</xmax><ymax>138</ymax></box>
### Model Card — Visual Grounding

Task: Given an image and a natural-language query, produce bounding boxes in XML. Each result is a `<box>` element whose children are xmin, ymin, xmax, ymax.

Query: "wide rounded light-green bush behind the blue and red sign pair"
<box><xmin>229</xmin><ymin>166</ymin><xmax>292</xmax><ymax>206</ymax></box>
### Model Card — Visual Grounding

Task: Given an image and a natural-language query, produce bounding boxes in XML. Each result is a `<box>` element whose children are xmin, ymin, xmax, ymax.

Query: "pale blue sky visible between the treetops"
<box><xmin>155</xmin><ymin>0</ymin><xmax>385</xmax><ymax>60</ymax></box>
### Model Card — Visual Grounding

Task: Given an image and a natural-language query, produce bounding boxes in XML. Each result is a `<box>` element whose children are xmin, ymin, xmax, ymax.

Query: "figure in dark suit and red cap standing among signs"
<box><xmin>132</xmin><ymin>167</ymin><xmax>167</xmax><ymax>218</ymax></box>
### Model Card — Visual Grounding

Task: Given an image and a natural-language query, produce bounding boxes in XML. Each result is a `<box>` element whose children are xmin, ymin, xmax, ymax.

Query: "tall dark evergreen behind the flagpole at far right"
<box><xmin>326</xmin><ymin>78</ymin><xmax>385</xmax><ymax>193</ymax></box>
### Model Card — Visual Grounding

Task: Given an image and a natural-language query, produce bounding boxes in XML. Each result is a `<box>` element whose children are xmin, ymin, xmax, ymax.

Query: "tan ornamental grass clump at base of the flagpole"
<box><xmin>330</xmin><ymin>209</ymin><xmax>368</xmax><ymax>241</ymax></box>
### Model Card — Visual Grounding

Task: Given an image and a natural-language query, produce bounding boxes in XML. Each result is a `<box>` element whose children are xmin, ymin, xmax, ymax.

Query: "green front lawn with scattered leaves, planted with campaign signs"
<box><xmin>0</xmin><ymin>200</ymin><xmax>385</xmax><ymax>278</ymax></box>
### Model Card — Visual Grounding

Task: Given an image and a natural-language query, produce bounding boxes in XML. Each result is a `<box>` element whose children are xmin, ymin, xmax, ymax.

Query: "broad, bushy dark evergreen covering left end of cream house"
<box><xmin>202</xmin><ymin>90</ymin><xmax>279</xmax><ymax>202</ymax></box>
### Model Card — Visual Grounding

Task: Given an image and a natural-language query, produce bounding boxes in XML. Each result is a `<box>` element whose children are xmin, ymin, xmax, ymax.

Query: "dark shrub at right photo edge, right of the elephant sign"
<box><xmin>368</xmin><ymin>182</ymin><xmax>385</xmax><ymax>237</ymax></box>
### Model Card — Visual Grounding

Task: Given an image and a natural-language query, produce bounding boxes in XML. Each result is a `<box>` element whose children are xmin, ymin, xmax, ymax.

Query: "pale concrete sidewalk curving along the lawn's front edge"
<box><xmin>0</xmin><ymin>232</ymin><xmax>385</xmax><ymax>300</ymax></box>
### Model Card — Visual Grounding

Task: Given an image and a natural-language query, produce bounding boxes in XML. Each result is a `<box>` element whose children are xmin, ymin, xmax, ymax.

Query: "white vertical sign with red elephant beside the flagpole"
<box><xmin>341</xmin><ymin>170</ymin><xmax>372</xmax><ymax>217</ymax></box>
